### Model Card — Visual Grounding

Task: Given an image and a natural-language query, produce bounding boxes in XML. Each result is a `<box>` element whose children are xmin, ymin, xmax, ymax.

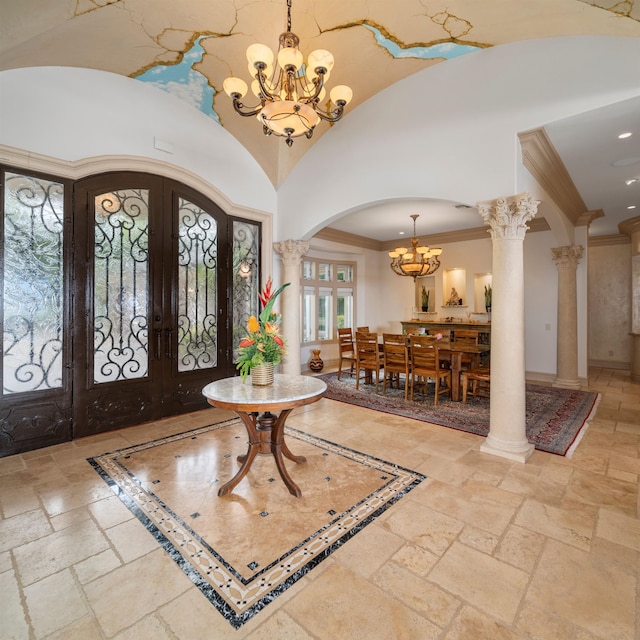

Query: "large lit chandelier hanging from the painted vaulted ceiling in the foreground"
<box><xmin>223</xmin><ymin>0</ymin><xmax>353</xmax><ymax>147</ymax></box>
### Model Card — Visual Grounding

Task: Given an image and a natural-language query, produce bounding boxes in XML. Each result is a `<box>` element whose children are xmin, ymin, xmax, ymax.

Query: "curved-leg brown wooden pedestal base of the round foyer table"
<box><xmin>218</xmin><ymin>409</ymin><xmax>306</xmax><ymax>498</ymax></box>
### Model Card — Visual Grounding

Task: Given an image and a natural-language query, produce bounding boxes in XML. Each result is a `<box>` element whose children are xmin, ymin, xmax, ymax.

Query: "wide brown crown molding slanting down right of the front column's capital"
<box><xmin>518</xmin><ymin>128</ymin><xmax>588</xmax><ymax>226</ymax></box>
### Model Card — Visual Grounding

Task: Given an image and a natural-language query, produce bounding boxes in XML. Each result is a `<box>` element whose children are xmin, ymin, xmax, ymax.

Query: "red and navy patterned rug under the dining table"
<box><xmin>319</xmin><ymin>373</ymin><xmax>600</xmax><ymax>457</ymax></box>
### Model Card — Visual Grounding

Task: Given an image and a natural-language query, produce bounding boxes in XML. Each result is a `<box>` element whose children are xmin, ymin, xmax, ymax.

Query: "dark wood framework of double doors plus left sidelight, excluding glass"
<box><xmin>0</xmin><ymin>165</ymin><xmax>245</xmax><ymax>457</ymax></box>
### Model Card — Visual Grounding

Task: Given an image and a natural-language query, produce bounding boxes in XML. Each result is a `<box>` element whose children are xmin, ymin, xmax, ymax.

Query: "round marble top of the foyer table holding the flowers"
<box><xmin>202</xmin><ymin>373</ymin><xmax>327</xmax><ymax>405</ymax></box>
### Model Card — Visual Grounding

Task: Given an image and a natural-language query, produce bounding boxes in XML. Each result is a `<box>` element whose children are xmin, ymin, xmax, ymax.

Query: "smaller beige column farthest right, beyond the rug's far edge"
<box><xmin>551</xmin><ymin>245</ymin><xmax>584</xmax><ymax>389</ymax></box>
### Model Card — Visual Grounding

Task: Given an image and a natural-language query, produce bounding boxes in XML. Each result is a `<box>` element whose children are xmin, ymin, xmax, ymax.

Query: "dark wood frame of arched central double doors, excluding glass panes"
<box><xmin>73</xmin><ymin>173</ymin><xmax>232</xmax><ymax>437</ymax></box>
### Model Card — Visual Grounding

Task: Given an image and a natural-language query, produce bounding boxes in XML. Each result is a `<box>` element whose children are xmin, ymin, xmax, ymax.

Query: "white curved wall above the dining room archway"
<box><xmin>278</xmin><ymin>36</ymin><xmax>640</xmax><ymax>244</ymax></box>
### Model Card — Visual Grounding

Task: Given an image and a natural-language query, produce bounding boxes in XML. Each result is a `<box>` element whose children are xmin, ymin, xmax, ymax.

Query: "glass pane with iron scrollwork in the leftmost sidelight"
<box><xmin>2</xmin><ymin>172</ymin><xmax>64</xmax><ymax>395</ymax></box>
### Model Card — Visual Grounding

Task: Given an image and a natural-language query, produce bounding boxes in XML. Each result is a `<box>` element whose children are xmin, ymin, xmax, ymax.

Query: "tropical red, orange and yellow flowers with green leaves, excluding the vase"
<box><xmin>236</xmin><ymin>277</ymin><xmax>291</xmax><ymax>381</ymax></box>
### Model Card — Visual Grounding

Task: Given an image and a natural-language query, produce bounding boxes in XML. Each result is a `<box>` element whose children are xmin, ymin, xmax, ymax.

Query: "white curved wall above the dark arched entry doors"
<box><xmin>0</xmin><ymin>67</ymin><xmax>276</xmax><ymax>214</ymax></box>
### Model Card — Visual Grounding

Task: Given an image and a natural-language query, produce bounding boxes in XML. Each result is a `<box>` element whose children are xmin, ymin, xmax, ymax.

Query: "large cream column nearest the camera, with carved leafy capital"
<box><xmin>478</xmin><ymin>193</ymin><xmax>539</xmax><ymax>462</ymax></box>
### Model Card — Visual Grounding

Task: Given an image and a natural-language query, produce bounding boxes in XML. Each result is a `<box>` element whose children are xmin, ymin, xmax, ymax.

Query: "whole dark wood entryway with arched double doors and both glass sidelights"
<box><xmin>0</xmin><ymin>172</ymin><xmax>260</xmax><ymax>455</ymax></box>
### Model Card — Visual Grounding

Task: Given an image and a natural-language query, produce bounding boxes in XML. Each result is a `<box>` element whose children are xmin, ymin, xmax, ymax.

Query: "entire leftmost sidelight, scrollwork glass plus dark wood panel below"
<box><xmin>0</xmin><ymin>171</ymin><xmax>71</xmax><ymax>456</ymax></box>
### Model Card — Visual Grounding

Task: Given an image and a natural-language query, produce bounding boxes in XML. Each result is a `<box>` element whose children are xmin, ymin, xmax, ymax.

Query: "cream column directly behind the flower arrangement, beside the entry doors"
<box><xmin>273</xmin><ymin>240</ymin><xmax>309</xmax><ymax>376</ymax></box>
